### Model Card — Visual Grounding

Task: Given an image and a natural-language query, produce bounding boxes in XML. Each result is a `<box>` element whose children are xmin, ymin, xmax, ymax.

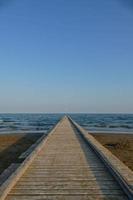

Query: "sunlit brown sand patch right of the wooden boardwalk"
<box><xmin>92</xmin><ymin>133</ymin><xmax>133</xmax><ymax>170</ymax></box>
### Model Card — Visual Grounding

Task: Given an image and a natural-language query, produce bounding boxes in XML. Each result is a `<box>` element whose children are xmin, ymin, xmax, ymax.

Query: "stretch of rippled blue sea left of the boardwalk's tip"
<box><xmin>0</xmin><ymin>114</ymin><xmax>63</xmax><ymax>133</ymax></box>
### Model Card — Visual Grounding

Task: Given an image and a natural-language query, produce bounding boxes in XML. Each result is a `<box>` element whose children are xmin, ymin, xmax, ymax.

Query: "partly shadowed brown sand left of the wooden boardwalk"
<box><xmin>0</xmin><ymin>134</ymin><xmax>42</xmax><ymax>174</ymax></box>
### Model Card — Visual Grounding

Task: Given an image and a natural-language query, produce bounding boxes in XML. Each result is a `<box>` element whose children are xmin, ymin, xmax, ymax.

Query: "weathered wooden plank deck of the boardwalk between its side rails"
<box><xmin>0</xmin><ymin>117</ymin><xmax>132</xmax><ymax>200</ymax></box>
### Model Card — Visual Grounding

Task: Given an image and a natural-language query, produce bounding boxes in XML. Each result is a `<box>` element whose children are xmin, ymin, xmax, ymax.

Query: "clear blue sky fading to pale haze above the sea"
<box><xmin>0</xmin><ymin>0</ymin><xmax>133</xmax><ymax>113</ymax></box>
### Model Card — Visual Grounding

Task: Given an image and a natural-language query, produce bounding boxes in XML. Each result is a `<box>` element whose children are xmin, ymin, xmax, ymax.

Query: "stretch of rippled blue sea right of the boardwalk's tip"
<box><xmin>71</xmin><ymin>114</ymin><xmax>133</xmax><ymax>133</ymax></box>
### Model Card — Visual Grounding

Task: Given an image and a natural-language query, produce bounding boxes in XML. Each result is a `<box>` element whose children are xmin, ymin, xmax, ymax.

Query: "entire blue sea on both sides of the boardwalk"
<box><xmin>0</xmin><ymin>114</ymin><xmax>133</xmax><ymax>133</ymax></box>
